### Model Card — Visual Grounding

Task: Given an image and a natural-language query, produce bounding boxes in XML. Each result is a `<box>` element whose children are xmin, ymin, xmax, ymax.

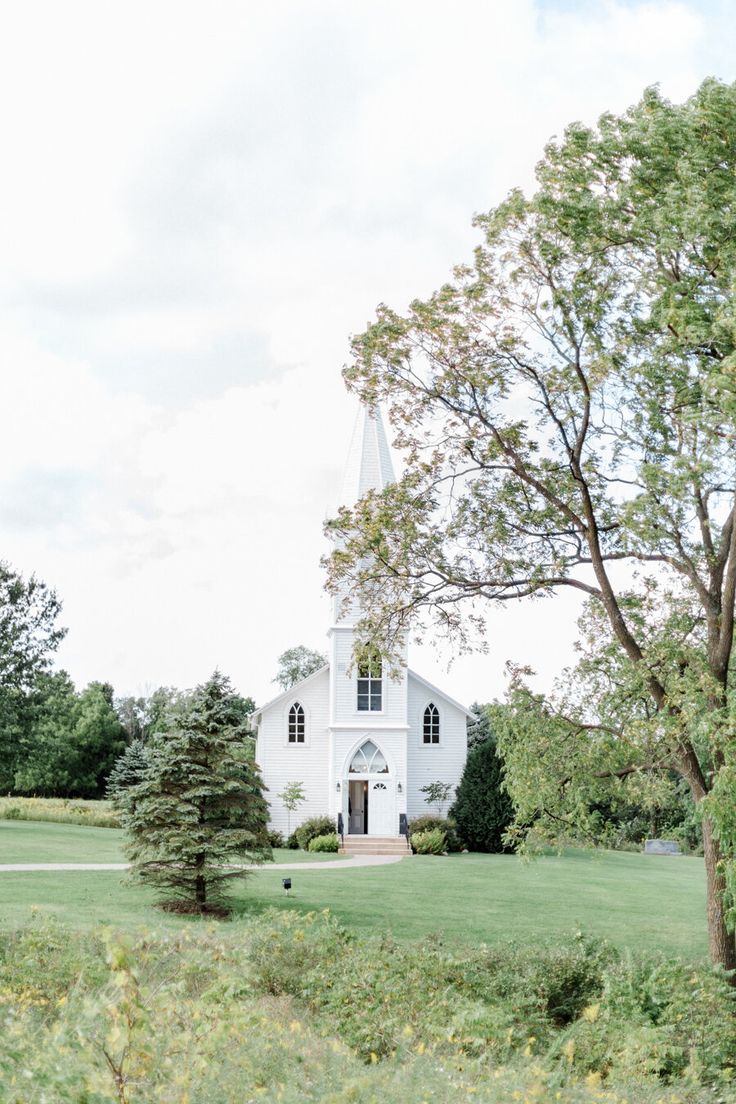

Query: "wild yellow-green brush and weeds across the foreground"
<box><xmin>0</xmin><ymin>912</ymin><xmax>736</xmax><ymax>1104</ymax></box>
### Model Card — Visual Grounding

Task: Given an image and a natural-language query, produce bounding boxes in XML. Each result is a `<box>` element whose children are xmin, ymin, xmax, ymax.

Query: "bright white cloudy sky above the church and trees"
<box><xmin>0</xmin><ymin>0</ymin><xmax>736</xmax><ymax>702</ymax></box>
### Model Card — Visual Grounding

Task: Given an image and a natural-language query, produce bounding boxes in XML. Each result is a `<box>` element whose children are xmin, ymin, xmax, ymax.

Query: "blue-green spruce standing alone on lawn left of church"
<box><xmin>122</xmin><ymin>671</ymin><xmax>270</xmax><ymax>914</ymax></box>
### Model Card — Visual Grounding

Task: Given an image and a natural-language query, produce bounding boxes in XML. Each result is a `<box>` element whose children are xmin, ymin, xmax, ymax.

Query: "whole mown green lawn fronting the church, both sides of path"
<box><xmin>0</xmin><ymin>821</ymin><xmax>707</xmax><ymax>958</ymax></box>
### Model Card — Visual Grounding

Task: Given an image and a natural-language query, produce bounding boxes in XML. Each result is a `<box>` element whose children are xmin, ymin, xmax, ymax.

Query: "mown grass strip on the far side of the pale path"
<box><xmin>0</xmin><ymin>820</ymin><xmax>343</xmax><ymax>865</ymax></box>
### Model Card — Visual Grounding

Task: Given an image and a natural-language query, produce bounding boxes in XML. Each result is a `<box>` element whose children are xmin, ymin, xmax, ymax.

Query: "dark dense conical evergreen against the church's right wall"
<box><xmin>450</xmin><ymin>737</ymin><xmax>513</xmax><ymax>852</ymax></box>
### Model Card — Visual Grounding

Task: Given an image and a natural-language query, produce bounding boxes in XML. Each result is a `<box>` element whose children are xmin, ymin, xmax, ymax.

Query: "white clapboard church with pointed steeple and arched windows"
<box><xmin>252</xmin><ymin>408</ymin><xmax>471</xmax><ymax>850</ymax></box>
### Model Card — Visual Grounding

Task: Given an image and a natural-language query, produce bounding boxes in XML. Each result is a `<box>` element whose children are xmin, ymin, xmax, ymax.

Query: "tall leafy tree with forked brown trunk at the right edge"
<box><xmin>330</xmin><ymin>81</ymin><xmax>736</xmax><ymax>968</ymax></box>
